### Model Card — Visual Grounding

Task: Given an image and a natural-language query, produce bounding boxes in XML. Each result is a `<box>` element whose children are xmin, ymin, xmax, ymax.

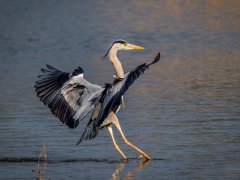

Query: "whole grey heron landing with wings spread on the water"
<box><xmin>34</xmin><ymin>40</ymin><xmax>160</xmax><ymax>159</ymax></box>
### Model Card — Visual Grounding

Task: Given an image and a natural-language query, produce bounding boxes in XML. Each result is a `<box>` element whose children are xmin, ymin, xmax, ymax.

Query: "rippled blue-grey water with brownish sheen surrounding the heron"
<box><xmin>0</xmin><ymin>0</ymin><xmax>240</xmax><ymax>179</ymax></box>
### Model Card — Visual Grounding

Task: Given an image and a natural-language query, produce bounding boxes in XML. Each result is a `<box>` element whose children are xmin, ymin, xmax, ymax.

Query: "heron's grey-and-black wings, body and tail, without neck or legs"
<box><xmin>35</xmin><ymin>53</ymin><xmax>160</xmax><ymax>144</ymax></box>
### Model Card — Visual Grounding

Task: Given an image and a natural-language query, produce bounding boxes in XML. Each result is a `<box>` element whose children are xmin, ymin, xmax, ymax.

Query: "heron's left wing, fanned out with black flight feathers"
<box><xmin>34</xmin><ymin>65</ymin><xmax>103</xmax><ymax>128</ymax></box>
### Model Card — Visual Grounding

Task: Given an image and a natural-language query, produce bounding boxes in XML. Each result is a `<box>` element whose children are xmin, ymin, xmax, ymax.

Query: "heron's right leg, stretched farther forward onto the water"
<box><xmin>112</xmin><ymin>113</ymin><xmax>152</xmax><ymax>159</ymax></box>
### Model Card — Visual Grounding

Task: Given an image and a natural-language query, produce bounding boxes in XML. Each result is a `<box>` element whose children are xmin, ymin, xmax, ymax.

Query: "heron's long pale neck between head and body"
<box><xmin>109</xmin><ymin>48</ymin><xmax>124</xmax><ymax>78</ymax></box>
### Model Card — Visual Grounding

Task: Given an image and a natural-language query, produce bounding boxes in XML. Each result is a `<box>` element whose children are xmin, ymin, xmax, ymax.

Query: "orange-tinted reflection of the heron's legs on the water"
<box><xmin>112</xmin><ymin>159</ymin><xmax>151</xmax><ymax>180</ymax></box>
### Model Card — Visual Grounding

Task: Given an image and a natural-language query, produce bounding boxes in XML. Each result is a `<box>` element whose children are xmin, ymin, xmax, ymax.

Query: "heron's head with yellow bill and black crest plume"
<box><xmin>102</xmin><ymin>39</ymin><xmax>144</xmax><ymax>59</ymax></box>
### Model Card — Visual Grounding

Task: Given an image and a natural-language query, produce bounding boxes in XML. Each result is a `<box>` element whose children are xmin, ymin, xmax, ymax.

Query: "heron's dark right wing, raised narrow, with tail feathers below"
<box><xmin>77</xmin><ymin>53</ymin><xmax>160</xmax><ymax>144</ymax></box>
